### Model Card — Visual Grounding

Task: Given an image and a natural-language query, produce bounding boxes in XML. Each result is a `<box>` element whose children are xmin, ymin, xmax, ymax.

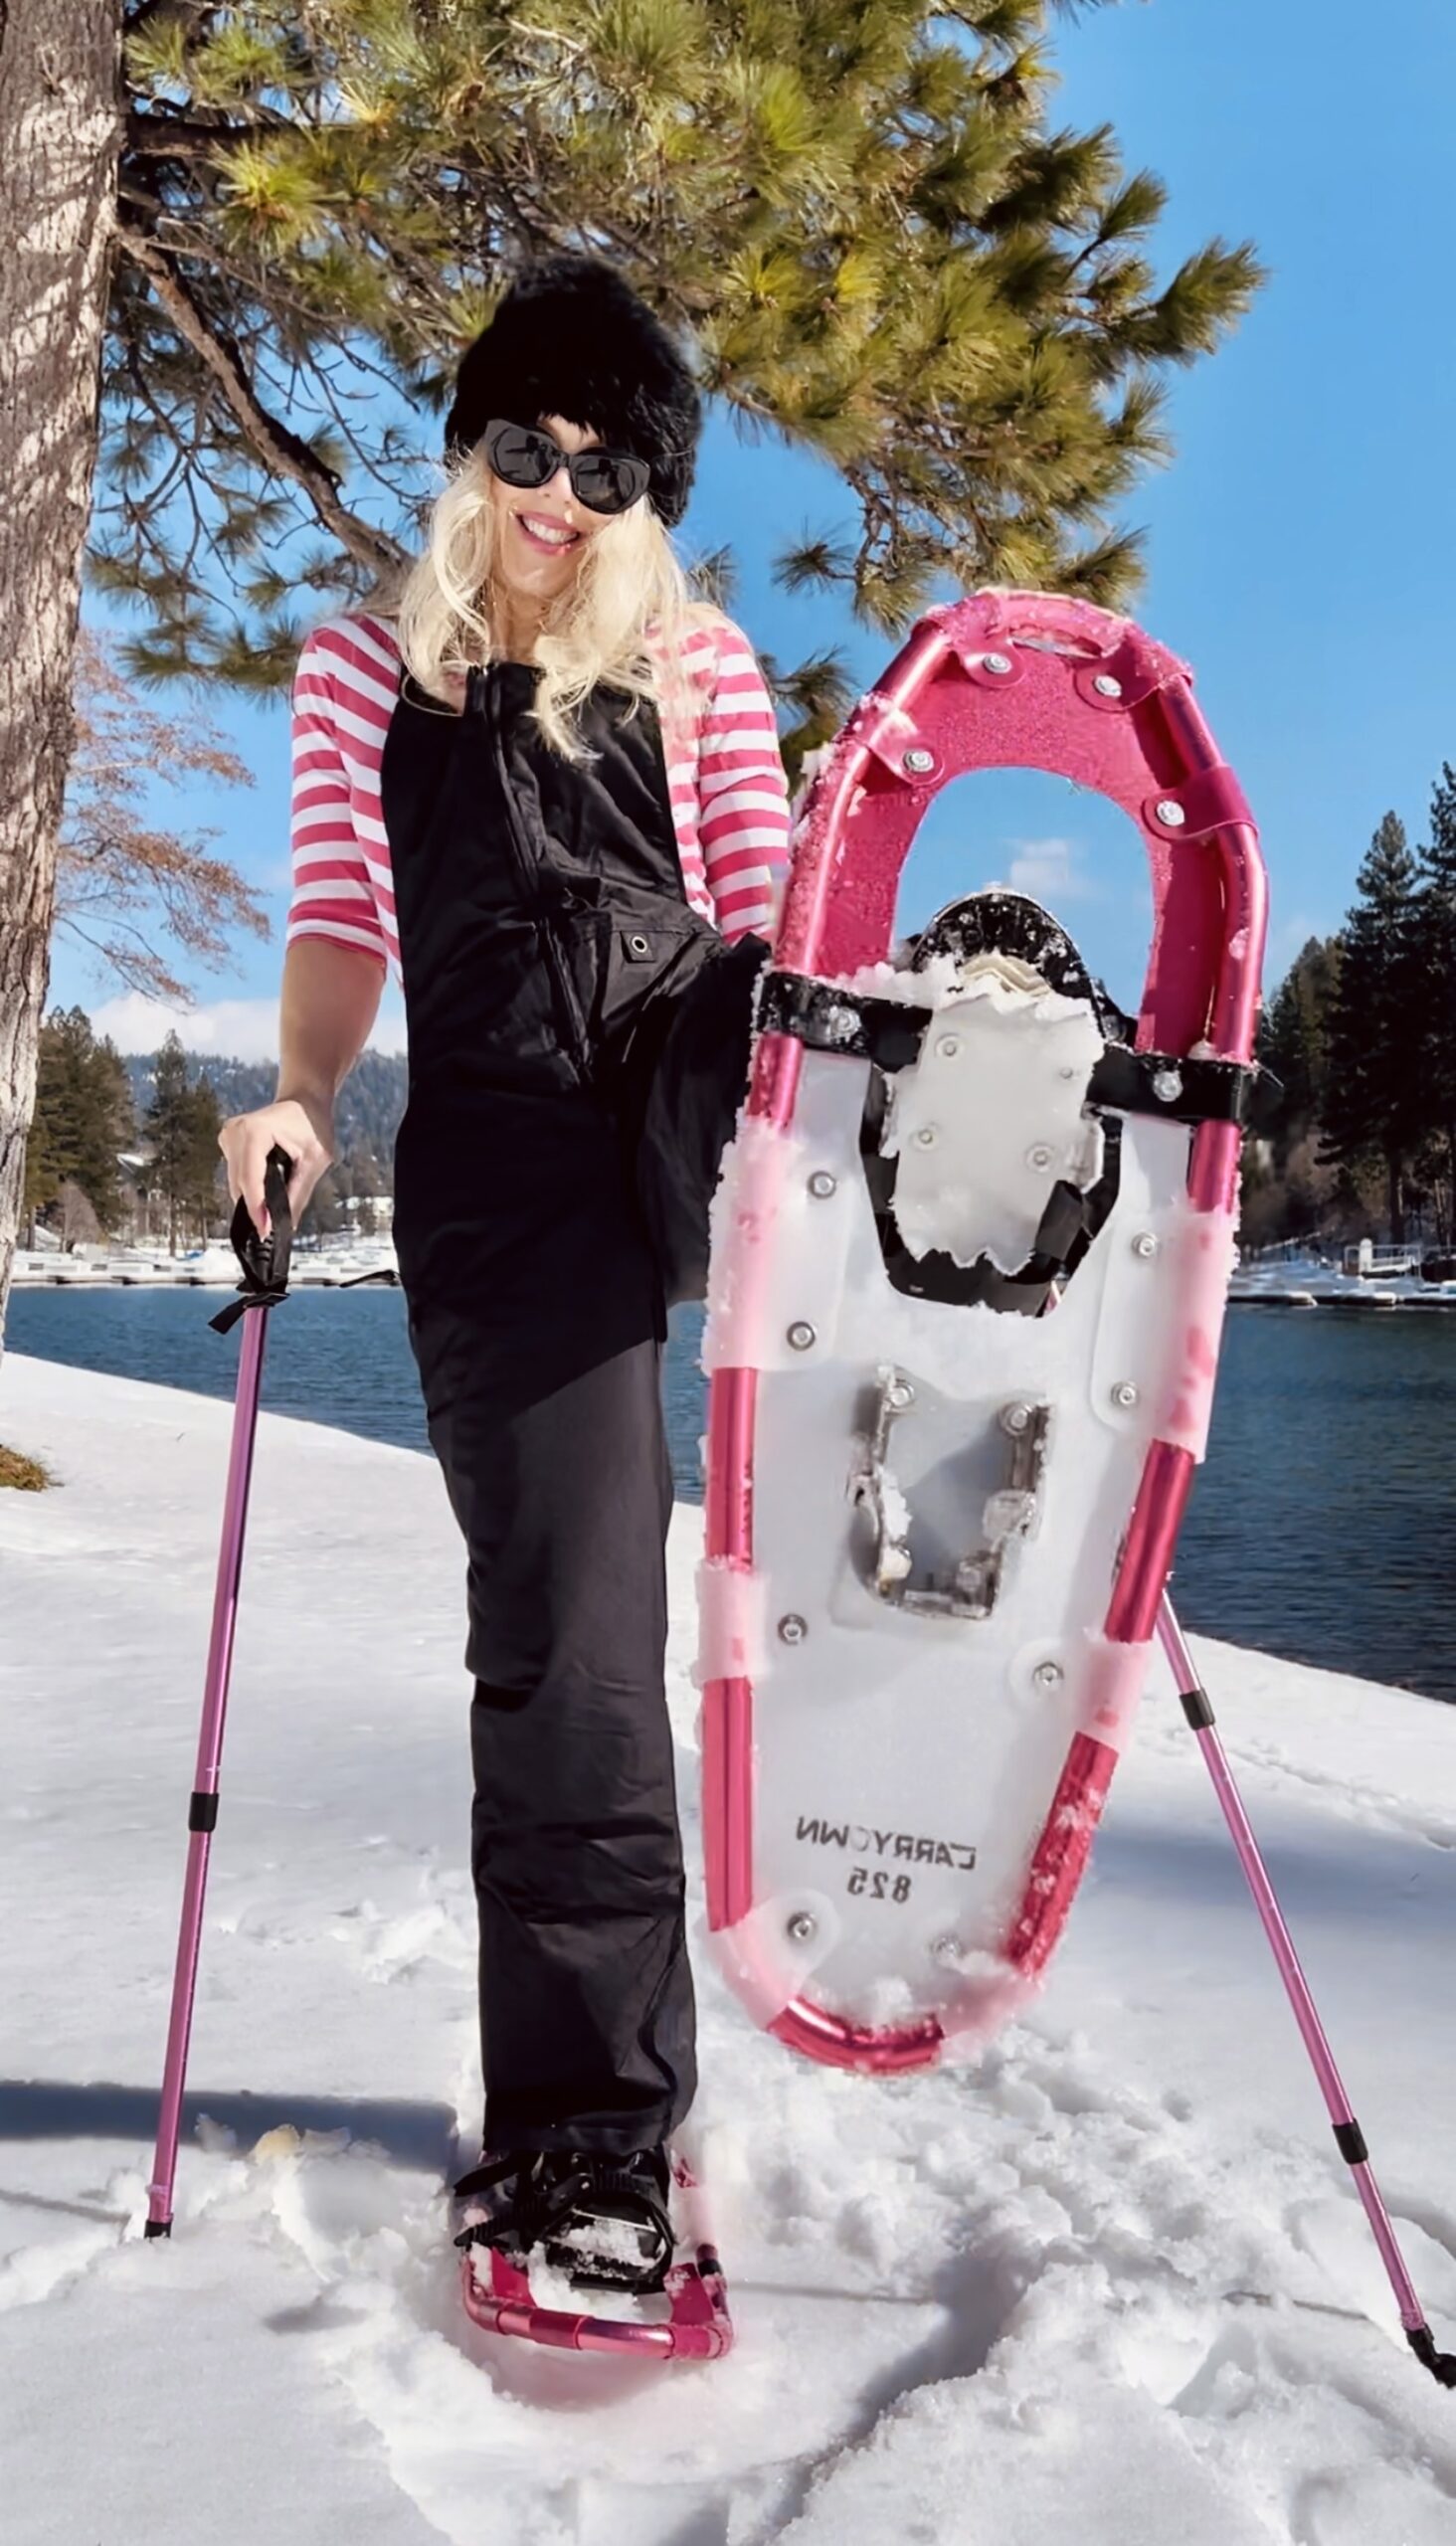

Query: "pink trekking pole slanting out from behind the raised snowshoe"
<box><xmin>1159</xmin><ymin>1594</ymin><xmax>1456</xmax><ymax>2388</ymax></box>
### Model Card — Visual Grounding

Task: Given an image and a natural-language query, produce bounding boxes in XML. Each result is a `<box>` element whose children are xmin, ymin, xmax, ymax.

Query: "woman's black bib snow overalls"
<box><xmin>382</xmin><ymin>664</ymin><xmax>769</xmax><ymax>2151</ymax></box>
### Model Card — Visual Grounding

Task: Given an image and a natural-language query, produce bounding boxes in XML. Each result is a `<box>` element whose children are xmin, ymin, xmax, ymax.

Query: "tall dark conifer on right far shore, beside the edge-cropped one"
<box><xmin>1324</xmin><ymin>813</ymin><xmax>1423</xmax><ymax>1245</ymax></box>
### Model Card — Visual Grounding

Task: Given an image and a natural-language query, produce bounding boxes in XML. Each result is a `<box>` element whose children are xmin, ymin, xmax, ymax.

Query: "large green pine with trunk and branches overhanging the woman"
<box><xmin>0</xmin><ymin>0</ymin><xmax>1260</xmax><ymax>1299</ymax></box>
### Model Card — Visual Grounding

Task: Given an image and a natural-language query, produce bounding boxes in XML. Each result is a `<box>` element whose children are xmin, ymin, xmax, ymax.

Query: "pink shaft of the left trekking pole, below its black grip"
<box><xmin>145</xmin><ymin>1309</ymin><xmax>270</xmax><ymax>2238</ymax></box>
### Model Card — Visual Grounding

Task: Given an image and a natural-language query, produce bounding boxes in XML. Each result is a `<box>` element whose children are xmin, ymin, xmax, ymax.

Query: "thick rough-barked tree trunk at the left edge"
<box><xmin>0</xmin><ymin>0</ymin><xmax>124</xmax><ymax>1334</ymax></box>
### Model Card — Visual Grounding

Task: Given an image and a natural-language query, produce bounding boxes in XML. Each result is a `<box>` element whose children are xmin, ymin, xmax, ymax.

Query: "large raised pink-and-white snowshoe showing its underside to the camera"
<box><xmin>697</xmin><ymin>593</ymin><xmax>1265</xmax><ymax>2070</ymax></box>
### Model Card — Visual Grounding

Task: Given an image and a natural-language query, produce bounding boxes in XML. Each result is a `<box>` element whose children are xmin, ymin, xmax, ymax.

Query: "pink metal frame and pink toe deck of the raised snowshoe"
<box><xmin>702</xmin><ymin>593</ymin><xmax>1265</xmax><ymax>2070</ymax></box>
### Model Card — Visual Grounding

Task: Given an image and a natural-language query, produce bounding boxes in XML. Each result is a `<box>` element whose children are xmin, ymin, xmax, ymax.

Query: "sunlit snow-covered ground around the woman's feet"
<box><xmin>0</xmin><ymin>1345</ymin><xmax>1456</xmax><ymax>2546</ymax></box>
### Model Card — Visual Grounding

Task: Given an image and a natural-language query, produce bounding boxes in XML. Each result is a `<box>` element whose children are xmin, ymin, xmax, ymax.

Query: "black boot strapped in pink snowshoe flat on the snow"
<box><xmin>455</xmin><ymin>2149</ymin><xmax>733</xmax><ymax>2360</ymax></box>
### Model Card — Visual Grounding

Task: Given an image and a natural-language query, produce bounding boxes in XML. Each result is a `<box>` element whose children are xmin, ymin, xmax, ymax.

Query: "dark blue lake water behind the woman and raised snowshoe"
<box><xmin>11</xmin><ymin>1288</ymin><xmax>1456</xmax><ymax>1701</ymax></box>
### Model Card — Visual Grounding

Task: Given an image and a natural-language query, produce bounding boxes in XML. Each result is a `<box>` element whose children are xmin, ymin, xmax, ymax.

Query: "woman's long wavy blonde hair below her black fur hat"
<box><xmin>369</xmin><ymin>443</ymin><xmax>723</xmax><ymax>761</ymax></box>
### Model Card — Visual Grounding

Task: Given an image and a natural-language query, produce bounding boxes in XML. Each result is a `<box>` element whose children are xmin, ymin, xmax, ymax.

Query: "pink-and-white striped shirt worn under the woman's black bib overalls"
<box><xmin>287</xmin><ymin>614</ymin><xmax>789</xmax><ymax>975</ymax></box>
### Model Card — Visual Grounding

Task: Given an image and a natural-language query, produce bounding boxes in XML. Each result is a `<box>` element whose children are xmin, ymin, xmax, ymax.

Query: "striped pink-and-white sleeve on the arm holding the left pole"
<box><xmin>285</xmin><ymin>629</ymin><xmax>390</xmax><ymax>963</ymax></box>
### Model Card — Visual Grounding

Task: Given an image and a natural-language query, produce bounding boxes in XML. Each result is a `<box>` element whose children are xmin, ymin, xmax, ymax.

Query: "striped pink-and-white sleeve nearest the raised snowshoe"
<box><xmin>697</xmin><ymin>622</ymin><xmax>789</xmax><ymax>945</ymax></box>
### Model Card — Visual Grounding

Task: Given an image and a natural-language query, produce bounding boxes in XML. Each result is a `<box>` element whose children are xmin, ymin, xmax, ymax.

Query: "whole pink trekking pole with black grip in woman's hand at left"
<box><xmin>145</xmin><ymin>1149</ymin><xmax>292</xmax><ymax>2238</ymax></box>
